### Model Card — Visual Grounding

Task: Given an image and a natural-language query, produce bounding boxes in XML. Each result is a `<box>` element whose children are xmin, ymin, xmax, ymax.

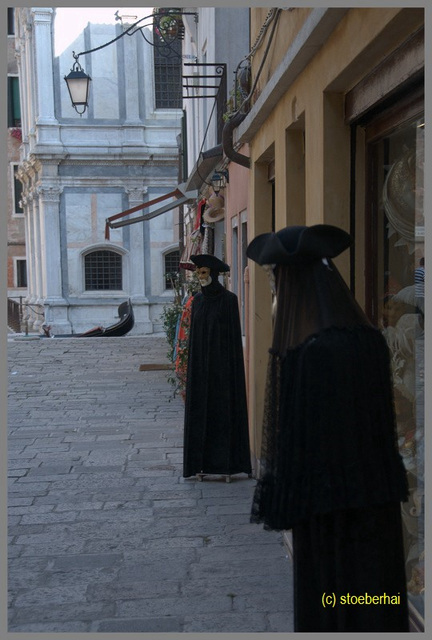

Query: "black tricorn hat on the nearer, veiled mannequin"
<box><xmin>246</xmin><ymin>224</ymin><xmax>353</xmax><ymax>264</ymax></box>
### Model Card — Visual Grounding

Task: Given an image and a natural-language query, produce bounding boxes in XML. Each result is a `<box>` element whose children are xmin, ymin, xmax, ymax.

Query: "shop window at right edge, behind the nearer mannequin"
<box><xmin>366</xmin><ymin>111</ymin><xmax>425</xmax><ymax>628</ymax></box>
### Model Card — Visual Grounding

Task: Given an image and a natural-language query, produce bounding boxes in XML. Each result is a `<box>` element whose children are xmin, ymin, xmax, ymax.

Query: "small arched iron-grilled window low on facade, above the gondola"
<box><xmin>84</xmin><ymin>249</ymin><xmax>123</xmax><ymax>291</ymax></box>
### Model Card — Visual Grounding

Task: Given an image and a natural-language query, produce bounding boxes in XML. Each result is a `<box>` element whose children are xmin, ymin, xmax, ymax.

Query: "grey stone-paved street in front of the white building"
<box><xmin>8</xmin><ymin>336</ymin><xmax>293</xmax><ymax>633</ymax></box>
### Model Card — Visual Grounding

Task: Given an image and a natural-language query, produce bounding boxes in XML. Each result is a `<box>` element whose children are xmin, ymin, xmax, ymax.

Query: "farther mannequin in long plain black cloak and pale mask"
<box><xmin>183</xmin><ymin>254</ymin><xmax>252</xmax><ymax>481</ymax></box>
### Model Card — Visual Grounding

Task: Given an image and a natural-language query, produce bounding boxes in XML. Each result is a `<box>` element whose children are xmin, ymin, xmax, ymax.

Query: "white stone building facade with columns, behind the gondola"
<box><xmin>16</xmin><ymin>7</ymin><xmax>182</xmax><ymax>334</ymax></box>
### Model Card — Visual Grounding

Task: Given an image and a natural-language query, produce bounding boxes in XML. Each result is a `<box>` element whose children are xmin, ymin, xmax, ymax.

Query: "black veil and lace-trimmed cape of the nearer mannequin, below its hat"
<box><xmin>251</xmin><ymin>235</ymin><xmax>407</xmax><ymax>529</ymax></box>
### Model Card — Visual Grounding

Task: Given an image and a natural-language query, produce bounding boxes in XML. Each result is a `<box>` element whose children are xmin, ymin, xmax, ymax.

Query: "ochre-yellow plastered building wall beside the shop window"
<box><xmin>243</xmin><ymin>8</ymin><xmax>423</xmax><ymax>464</ymax></box>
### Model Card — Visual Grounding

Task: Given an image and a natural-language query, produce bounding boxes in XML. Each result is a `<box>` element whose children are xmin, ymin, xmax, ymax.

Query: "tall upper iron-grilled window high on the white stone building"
<box><xmin>154</xmin><ymin>40</ymin><xmax>182</xmax><ymax>109</ymax></box>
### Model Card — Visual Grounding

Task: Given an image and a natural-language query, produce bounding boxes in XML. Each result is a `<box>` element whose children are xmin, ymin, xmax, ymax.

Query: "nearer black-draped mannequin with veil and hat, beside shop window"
<box><xmin>247</xmin><ymin>225</ymin><xmax>408</xmax><ymax>632</ymax></box>
